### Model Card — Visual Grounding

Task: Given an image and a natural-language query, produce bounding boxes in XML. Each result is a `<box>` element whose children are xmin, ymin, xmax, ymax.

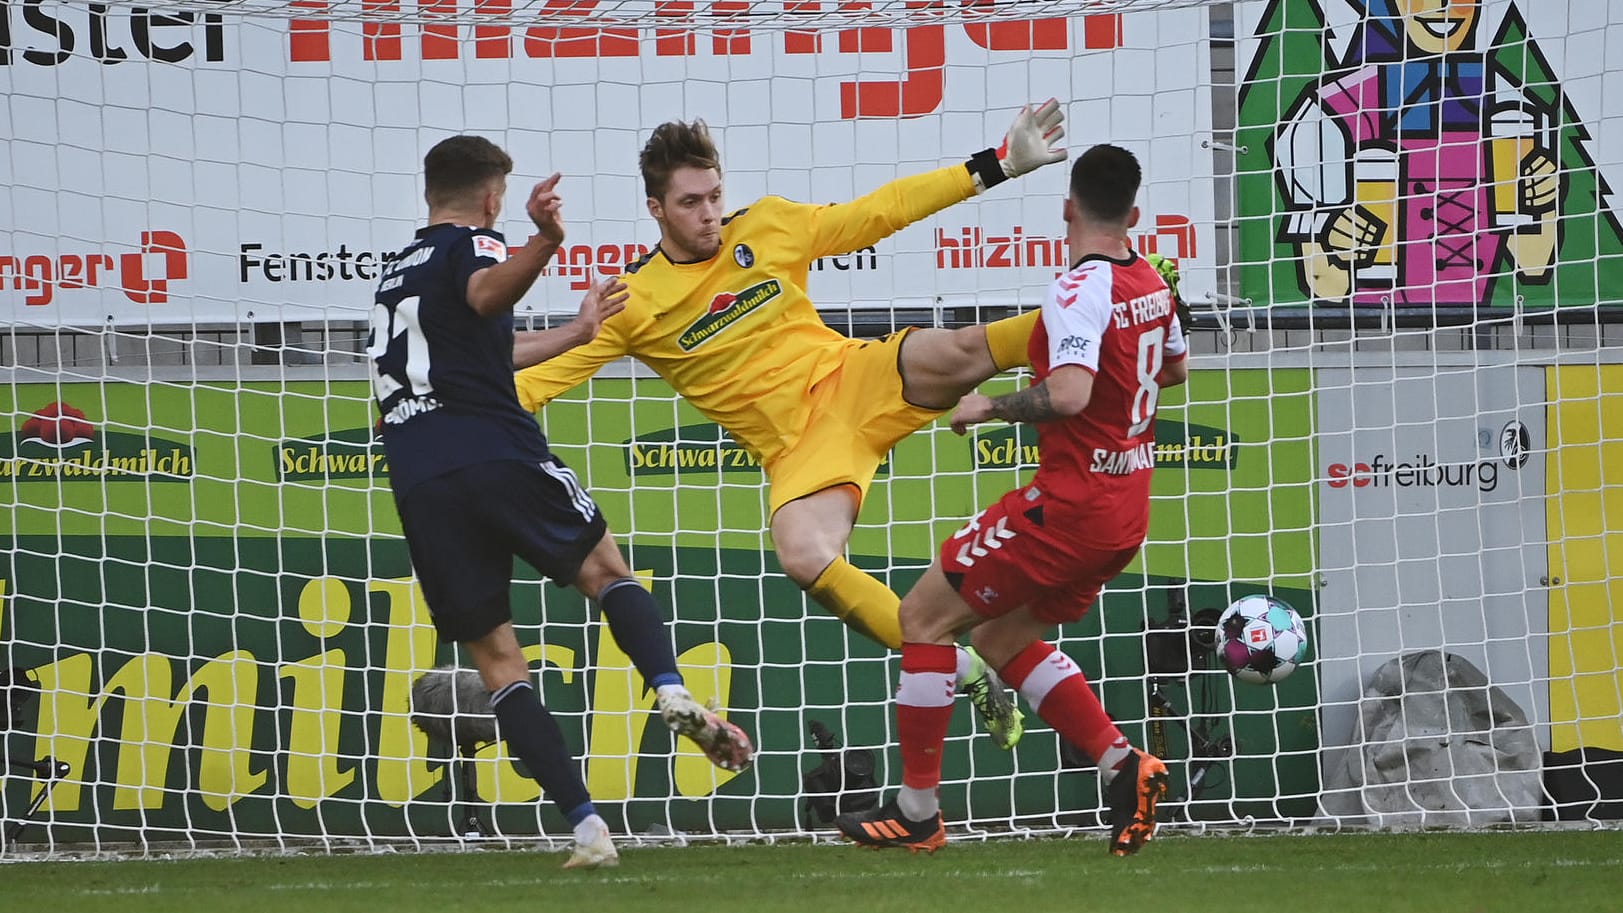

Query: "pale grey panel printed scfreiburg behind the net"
<box><xmin>1316</xmin><ymin>363</ymin><xmax>1550</xmax><ymax>758</ymax></box>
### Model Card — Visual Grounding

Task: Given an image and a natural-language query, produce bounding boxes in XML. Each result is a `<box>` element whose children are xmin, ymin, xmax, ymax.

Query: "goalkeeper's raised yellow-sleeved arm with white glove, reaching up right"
<box><xmin>807</xmin><ymin>99</ymin><xmax>1066</xmax><ymax>259</ymax></box>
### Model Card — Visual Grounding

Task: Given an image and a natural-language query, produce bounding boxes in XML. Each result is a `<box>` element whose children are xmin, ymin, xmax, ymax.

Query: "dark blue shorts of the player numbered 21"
<box><xmin>394</xmin><ymin>457</ymin><xmax>607</xmax><ymax>642</ymax></box>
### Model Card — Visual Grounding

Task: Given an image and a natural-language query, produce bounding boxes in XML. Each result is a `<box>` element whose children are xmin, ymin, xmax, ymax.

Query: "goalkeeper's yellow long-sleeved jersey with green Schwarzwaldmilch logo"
<box><xmin>514</xmin><ymin>164</ymin><xmax>975</xmax><ymax>464</ymax></box>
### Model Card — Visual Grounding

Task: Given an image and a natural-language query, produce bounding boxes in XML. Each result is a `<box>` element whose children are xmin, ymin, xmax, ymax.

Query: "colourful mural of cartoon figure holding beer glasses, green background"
<box><xmin>1238</xmin><ymin>0</ymin><xmax>1623</xmax><ymax>308</ymax></box>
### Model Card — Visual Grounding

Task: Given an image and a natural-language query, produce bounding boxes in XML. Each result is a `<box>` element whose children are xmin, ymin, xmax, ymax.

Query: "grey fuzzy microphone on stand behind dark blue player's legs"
<box><xmin>411</xmin><ymin>667</ymin><xmax>497</xmax><ymax>837</ymax></box>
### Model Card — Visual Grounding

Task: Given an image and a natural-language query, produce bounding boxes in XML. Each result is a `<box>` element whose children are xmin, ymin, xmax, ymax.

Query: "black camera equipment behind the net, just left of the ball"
<box><xmin>1144</xmin><ymin>581</ymin><xmax>1235</xmax><ymax>821</ymax></box>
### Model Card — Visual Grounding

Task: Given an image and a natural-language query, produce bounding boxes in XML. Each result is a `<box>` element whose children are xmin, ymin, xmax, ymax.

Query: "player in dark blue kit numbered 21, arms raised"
<box><xmin>367</xmin><ymin>136</ymin><xmax>755</xmax><ymax>868</ymax></box>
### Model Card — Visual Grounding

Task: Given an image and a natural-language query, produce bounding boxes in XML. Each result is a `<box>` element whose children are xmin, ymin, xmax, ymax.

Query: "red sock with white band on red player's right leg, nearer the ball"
<box><xmin>998</xmin><ymin>641</ymin><xmax>1130</xmax><ymax>769</ymax></box>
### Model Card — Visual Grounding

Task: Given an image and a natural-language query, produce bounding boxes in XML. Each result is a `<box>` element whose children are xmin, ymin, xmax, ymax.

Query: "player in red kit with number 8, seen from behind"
<box><xmin>836</xmin><ymin>146</ymin><xmax>1188</xmax><ymax>856</ymax></box>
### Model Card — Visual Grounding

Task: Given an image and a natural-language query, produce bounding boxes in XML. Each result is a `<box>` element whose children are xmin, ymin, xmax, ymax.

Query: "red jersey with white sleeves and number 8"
<box><xmin>1029</xmin><ymin>253</ymin><xmax>1188</xmax><ymax>548</ymax></box>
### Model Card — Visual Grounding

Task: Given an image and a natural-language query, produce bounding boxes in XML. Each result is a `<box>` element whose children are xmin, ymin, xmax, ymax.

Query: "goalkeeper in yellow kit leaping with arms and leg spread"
<box><xmin>514</xmin><ymin>99</ymin><xmax>1065</xmax><ymax>748</ymax></box>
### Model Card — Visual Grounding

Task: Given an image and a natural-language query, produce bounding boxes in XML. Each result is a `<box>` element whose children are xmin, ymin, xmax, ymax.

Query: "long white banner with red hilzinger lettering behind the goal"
<box><xmin>0</xmin><ymin>0</ymin><xmax>1216</xmax><ymax>326</ymax></box>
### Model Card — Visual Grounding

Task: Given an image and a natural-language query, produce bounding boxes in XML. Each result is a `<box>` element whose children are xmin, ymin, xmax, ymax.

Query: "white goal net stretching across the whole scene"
<box><xmin>0</xmin><ymin>0</ymin><xmax>1623</xmax><ymax>855</ymax></box>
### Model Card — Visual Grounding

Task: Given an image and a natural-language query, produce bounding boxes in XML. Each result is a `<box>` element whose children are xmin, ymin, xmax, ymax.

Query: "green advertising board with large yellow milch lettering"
<box><xmin>0</xmin><ymin>371</ymin><xmax>1318</xmax><ymax>840</ymax></box>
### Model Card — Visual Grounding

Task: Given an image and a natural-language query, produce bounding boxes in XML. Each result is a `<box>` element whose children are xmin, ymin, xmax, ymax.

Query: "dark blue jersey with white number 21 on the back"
<box><xmin>367</xmin><ymin>224</ymin><xmax>549</xmax><ymax>496</ymax></box>
